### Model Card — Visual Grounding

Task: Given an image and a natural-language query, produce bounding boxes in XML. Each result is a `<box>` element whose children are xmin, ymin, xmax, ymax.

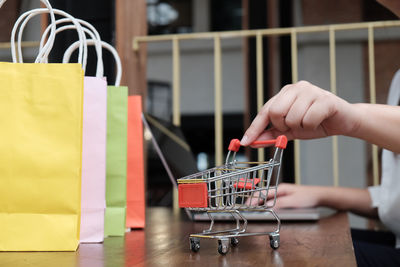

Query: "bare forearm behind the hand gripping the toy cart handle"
<box><xmin>350</xmin><ymin>104</ymin><xmax>400</xmax><ymax>153</ymax></box>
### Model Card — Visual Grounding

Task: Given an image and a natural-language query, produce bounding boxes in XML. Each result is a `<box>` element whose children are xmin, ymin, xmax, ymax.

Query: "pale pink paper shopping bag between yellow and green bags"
<box><xmin>80</xmin><ymin>77</ymin><xmax>107</xmax><ymax>243</ymax></box>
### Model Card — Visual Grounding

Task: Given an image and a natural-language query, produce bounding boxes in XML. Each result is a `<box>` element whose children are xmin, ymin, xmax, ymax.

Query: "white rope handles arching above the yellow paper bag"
<box><xmin>11</xmin><ymin>8</ymin><xmax>86</xmax><ymax>64</ymax></box>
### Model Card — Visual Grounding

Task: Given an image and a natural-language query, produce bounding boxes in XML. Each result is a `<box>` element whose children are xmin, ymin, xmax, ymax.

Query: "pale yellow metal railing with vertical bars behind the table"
<box><xmin>133</xmin><ymin>21</ymin><xmax>400</xmax><ymax>186</ymax></box>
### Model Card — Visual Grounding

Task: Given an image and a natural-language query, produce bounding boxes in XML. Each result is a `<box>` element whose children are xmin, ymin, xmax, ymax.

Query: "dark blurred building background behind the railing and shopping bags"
<box><xmin>0</xmin><ymin>0</ymin><xmax>400</xmax><ymax>230</ymax></box>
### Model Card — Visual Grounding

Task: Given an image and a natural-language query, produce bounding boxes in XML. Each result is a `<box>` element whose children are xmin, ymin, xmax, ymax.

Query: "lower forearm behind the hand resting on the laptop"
<box><xmin>318</xmin><ymin>186</ymin><xmax>378</xmax><ymax>218</ymax></box>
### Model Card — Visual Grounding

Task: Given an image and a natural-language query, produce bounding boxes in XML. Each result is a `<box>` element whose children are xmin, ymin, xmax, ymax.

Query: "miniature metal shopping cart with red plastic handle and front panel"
<box><xmin>178</xmin><ymin>135</ymin><xmax>287</xmax><ymax>254</ymax></box>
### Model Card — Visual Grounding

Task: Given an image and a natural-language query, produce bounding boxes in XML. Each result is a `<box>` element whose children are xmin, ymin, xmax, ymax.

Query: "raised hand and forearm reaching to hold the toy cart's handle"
<box><xmin>241</xmin><ymin>81</ymin><xmax>400</xmax><ymax>153</ymax></box>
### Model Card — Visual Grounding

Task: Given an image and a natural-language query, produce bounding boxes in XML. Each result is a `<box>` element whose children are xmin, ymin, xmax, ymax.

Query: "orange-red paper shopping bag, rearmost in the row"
<box><xmin>126</xmin><ymin>96</ymin><xmax>145</xmax><ymax>228</ymax></box>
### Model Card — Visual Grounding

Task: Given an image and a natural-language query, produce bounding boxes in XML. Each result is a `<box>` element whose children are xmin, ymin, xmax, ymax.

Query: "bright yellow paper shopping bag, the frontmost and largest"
<box><xmin>0</xmin><ymin>63</ymin><xmax>83</xmax><ymax>251</ymax></box>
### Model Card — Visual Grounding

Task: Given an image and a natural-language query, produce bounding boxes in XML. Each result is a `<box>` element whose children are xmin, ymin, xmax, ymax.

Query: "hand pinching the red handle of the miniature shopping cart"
<box><xmin>241</xmin><ymin>81</ymin><xmax>360</xmax><ymax>147</ymax></box>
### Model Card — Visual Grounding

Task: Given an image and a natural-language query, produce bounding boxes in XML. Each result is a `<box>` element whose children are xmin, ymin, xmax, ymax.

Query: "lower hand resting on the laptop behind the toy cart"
<box><xmin>246</xmin><ymin>183</ymin><xmax>321</xmax><ymax>209</ymax></box>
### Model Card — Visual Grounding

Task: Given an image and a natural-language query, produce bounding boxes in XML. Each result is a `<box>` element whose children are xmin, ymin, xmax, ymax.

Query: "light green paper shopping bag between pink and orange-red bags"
<box><xmin>104</xmin><ymin>86</ymin><xmax>128</xmax><ymax>236</ymax></box>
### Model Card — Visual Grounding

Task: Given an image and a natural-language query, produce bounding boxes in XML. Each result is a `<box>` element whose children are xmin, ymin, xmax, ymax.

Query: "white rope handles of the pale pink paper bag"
<box><xmin>40</xmin><ymin>18</ymin><xmax>104</xmax><ymax>77</ymax></box>
